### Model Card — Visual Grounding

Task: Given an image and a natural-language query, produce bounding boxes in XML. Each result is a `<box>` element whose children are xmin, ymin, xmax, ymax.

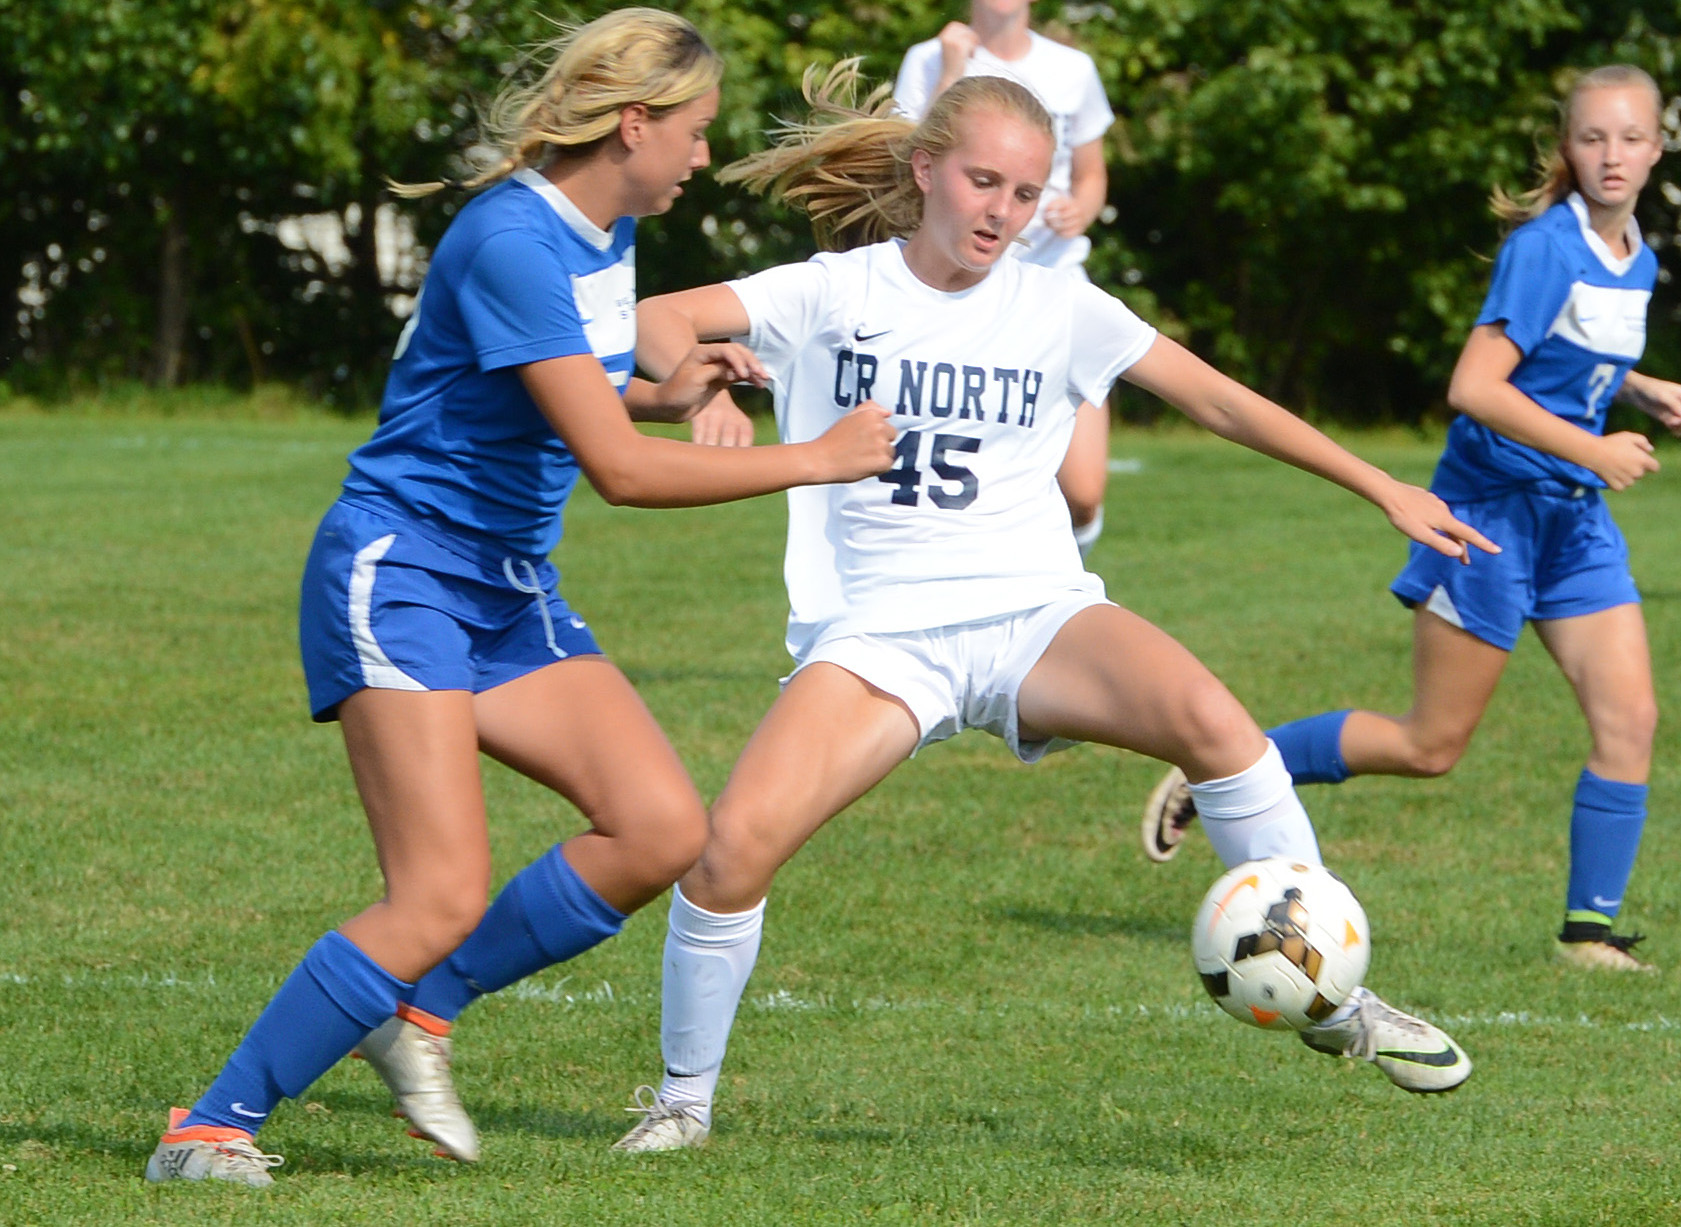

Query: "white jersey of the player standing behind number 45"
<box><xmin>893</xmin><ymin>32</ymin><xmax>1115</xmax><ymax>269</ymax></box>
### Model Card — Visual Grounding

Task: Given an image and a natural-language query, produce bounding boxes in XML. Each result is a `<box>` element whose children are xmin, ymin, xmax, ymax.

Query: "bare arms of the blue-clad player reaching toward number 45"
<box><xmin>519</xmin><ymin>346</ymin><xmax>894</xmax><ymax>508</ymax></box>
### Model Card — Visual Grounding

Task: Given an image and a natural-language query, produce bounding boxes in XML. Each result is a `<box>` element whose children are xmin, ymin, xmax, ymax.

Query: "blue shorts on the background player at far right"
<box><xmin>1389</xmin><ymin>487</ymin><xmax>1641</xmax><ymax>652</ymax></box>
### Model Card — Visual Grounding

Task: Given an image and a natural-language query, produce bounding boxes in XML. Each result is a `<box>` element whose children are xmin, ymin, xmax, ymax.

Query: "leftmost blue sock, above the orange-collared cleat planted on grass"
<box><xmin>182</xmin><ymin>931</ymin><xmax>412</xmax><ymax>1133</ymax></box>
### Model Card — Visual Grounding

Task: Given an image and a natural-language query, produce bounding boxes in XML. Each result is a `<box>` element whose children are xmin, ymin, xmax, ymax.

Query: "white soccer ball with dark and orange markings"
<box><xmin>1190</xmin><ymin>857</ymin><xmax>1372</xmax><ymax>1030</ymax></box>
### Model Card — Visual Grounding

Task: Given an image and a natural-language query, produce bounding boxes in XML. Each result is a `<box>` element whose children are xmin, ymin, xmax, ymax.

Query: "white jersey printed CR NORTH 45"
<box><xmin>730</xmin><ymin>240</ymin><xmax>1155</xmax><ymax>659</ymax></box>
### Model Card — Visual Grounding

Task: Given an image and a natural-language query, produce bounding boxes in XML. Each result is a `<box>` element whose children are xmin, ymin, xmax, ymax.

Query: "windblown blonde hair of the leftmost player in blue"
<box><xmin>392</xmin><ymin>8</ymin><xmax>725</xmax><ymax>197</ymax></box>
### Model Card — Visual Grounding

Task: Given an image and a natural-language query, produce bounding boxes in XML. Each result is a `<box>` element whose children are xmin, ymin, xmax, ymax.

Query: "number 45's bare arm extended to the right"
<box><xmin>1123</xmin><ymin>336</ymin><xmax>1499</xmax><ymax>560</ymax></box>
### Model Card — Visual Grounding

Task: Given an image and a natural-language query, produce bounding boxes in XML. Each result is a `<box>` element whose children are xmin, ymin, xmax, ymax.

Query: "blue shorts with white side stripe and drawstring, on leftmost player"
<box><xmin>298</xmin><ymin>499</ymin><xmax>602</xmax><ymax>721</ymax></box>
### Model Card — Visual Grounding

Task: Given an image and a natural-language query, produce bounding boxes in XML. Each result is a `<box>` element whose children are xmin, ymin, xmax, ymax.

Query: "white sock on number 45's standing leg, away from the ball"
<box><xmin>659</xmin><ymin>886</ymin><xmax>765</xmax><ymax>1124</ymax></box>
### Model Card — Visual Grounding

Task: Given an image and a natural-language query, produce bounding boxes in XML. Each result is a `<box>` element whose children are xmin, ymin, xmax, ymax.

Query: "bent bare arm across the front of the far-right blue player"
<box><xmin>1447</xmin><ymin>324</ymin><xmax>1657</xmax><ymax>489</ymax></box>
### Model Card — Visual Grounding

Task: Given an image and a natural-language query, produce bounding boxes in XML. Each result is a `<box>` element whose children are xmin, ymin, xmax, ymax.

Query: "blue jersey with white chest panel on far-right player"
<box><xmin>1431</xmin><ymin>193</ymin><xmax>1657</xmax><ymax>503</ymax></box>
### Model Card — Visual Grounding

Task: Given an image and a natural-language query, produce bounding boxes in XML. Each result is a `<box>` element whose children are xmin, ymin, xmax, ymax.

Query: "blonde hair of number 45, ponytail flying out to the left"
<box><xmin>718</xmin><ymin>57</ymin><xmax>1056</xmax><ymax>250</ymax></box>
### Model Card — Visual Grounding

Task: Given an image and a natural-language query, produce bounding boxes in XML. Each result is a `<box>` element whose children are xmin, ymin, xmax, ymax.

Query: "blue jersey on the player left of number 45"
<box><xmin>345</xmin><ymin>170</ymin><xmax>635</xmax><ymax>556</ymax></box>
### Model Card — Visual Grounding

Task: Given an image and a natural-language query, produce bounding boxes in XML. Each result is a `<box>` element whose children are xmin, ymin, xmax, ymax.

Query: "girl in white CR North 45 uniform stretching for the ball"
<box><xmin>619</xmin><ymin>66</ymin><xmax>1491</xmax><ymax>1150</ymax></box>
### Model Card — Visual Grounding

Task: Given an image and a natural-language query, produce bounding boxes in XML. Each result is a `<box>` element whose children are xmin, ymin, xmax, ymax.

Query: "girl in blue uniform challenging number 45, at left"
<box><xmin>146</xmin><ymin>8</ymin><xmax>893</xmax><ymax>1187</ymax></box>
